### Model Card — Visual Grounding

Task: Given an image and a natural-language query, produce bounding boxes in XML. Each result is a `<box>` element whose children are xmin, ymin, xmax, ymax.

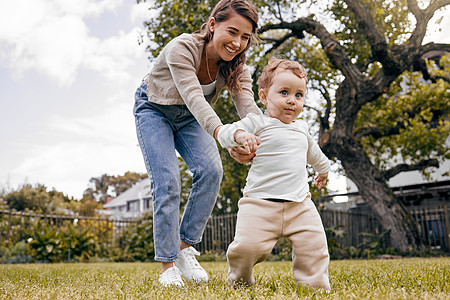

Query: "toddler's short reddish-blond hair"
<box><xmin>258</xmin><ymin>58</ymin><xmax>308</xmax><ymax>91</ymax></box>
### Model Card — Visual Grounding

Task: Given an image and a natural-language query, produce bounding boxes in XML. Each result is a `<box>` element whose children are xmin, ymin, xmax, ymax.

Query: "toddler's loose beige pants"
<box><xmin>227</xmin><ymin>197</ymin><xmax>330</xmax><ymax>290</ymax></box>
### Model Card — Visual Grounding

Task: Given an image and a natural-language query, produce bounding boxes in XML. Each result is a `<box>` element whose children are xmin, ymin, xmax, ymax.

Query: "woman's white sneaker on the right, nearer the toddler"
<box><xmin>175</xmin><ymin>246</ymin><xmax>208</xmax><ymax>282</ymax></box>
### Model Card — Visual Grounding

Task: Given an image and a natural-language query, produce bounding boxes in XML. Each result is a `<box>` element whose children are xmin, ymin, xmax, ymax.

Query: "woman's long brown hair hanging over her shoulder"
<box><xmin>200</xmin><ymin>0</ymin><xmax>258</xmax><ymax>92</ymax></box>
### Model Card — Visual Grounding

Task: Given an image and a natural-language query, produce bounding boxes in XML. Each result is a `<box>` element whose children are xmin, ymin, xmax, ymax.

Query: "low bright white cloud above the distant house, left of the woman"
<box><xmin>9</xmin><ymin>104</ymin><xmax>145</xmax><ymax>198</ymax></box>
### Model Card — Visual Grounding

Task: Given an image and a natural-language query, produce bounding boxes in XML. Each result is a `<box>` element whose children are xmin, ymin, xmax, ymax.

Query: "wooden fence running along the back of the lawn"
<box><xmin>0</xmin><ymin>206</ymin><xmax>450</xmax><ymax>253</ymax></box>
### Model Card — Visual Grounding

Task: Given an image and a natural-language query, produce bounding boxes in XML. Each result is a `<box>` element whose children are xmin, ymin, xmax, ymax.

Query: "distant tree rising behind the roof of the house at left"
<box><xmin>83</xmin><ymin>171</ymin><xmax>148</xmax><ymax>203</ymax></box>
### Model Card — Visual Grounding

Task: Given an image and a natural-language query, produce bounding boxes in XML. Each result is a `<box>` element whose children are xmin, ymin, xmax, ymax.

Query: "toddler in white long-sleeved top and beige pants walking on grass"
<box><xmin>218</xmin><ymin>59</ymin><xmax>330</xmax><ymax>290</ymax></box>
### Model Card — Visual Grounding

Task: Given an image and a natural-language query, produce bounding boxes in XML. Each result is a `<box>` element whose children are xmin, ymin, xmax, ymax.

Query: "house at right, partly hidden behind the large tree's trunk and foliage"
<box><xmin>323</xmin><ymin>161</ymin><xmax>450</xmax><ymax>253</ymax></box>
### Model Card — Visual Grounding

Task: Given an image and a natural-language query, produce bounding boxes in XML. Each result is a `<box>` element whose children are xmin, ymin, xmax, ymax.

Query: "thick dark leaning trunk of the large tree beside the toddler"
<box><xmin>321</xmin><ymin>81</ymin><xmax>420</xmax><ymax>251</ymax></box>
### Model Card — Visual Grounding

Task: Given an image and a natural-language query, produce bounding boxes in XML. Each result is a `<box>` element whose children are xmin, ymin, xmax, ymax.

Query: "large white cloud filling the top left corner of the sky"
<box><xmin>0</xmin><ymin>0</ymin><xmax>145</xmax><ymax>86</ymax></box>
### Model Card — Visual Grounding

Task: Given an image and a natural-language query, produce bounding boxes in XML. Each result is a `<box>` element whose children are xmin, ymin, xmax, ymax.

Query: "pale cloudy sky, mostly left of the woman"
<box><xmin>0</xmin><ymin>0</ymin><xmax>450</xmax><ymax>199</ymax></box>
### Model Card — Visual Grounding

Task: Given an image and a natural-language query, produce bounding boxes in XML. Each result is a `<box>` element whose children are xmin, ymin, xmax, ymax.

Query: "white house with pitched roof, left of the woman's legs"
<box><xmin>103</xmin><ymin>177</ymin><xmax>153</xmax><ymax>219</ymax></box>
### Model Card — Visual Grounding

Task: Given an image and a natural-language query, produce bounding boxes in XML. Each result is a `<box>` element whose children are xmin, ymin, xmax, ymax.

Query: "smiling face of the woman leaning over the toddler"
<box><xmin>208</xmin><ymin>13</ymin><xmax>253</xmax><ymax>61</ymax></box>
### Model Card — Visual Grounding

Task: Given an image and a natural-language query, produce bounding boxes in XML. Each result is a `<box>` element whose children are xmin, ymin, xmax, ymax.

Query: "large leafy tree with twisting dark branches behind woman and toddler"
<box><xmin>138</xmin><ymin>0</ymin><xmax>450</xmax><ymax>251</ymax></box>
